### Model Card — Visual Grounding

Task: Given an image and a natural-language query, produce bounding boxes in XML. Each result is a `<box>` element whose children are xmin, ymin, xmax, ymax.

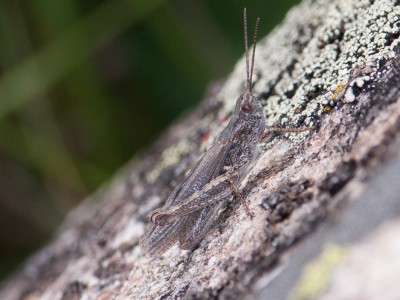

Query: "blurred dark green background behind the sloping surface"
<box><xmin>0</xmin><ymin>0</ymin><xmax>298</xmax><ymax>279</ymax></box>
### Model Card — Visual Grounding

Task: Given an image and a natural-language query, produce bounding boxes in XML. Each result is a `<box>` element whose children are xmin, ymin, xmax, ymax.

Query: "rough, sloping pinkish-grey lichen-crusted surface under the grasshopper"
<box><xmin>0</xmin><ymin>0</ymin><xmax>400</xmax><ymax>299</ymax></box>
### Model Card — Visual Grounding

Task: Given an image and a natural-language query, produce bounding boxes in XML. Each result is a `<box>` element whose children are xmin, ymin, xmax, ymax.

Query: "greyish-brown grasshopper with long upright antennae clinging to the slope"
<box><xmin>141</xmin><ymin>9</ymin><xmax>310</xmax><ymax>255</ymax></box>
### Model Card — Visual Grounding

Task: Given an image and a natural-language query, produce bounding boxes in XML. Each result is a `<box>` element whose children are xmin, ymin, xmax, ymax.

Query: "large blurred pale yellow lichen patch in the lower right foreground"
<box><xmin>289</xmin><ymin>244</ymin><xmax>348</xmax><ymax>300</ymax></box>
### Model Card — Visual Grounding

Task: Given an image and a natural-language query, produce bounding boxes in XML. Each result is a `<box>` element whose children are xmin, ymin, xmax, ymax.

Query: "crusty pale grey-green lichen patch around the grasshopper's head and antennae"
<box><xmin>221</xmin><ymin>0</ymin><xmax>400</xmax><ymax>137</ymax></box>
